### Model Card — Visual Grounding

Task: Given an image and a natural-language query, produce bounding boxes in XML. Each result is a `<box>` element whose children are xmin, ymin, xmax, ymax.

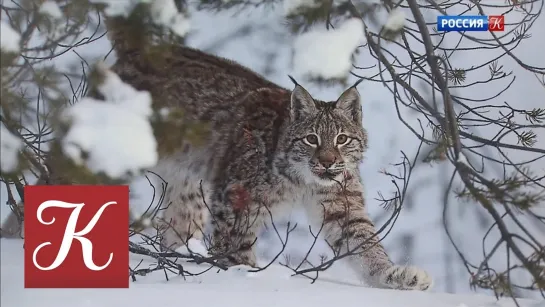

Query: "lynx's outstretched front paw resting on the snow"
<box><xmin>381</xmin><ymin>265</ymin><xmax>433</xmax><ymax>291</ymax></box>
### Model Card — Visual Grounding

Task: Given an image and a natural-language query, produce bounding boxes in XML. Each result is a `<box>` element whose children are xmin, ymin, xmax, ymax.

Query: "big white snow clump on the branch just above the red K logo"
<box><xmin>62</xmin><ymin>63</ymin><xmax>158</xmax><ymax>178</ymax></box>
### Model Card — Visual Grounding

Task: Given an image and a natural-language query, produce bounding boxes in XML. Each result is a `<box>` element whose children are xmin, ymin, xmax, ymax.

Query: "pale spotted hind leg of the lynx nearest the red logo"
<box><xmin>160</xmin><ymin>178</ymin><xmax>209</xmax><ymax>250</ymax></box>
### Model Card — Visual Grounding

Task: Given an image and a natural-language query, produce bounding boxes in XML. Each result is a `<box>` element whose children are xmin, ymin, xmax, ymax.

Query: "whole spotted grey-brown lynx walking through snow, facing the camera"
<box><xmin>108</xmin><ymin>26</ymin><xmax>432</xmax><ymax>290</ymax></box>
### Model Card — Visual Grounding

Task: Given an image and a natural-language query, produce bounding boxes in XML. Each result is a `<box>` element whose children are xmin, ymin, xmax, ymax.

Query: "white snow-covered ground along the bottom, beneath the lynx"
<box><xmin>0</xmin><ymin>239</ymin><xmax>543</xmax><ymax>307</ymax></box>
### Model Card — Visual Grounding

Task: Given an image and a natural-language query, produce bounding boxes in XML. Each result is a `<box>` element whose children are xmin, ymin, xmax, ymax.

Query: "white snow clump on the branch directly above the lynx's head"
<box><xmin>293</xmin><ymin>18</ymin><xmax>365</xmax><ymax>79</ymax></box>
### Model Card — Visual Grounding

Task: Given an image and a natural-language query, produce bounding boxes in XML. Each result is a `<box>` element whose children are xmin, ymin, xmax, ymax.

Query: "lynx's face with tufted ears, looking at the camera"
<box><xmin>287</xmin><ymin>85</ymin><xmax>367</xmax><ymax>185</ymax></box>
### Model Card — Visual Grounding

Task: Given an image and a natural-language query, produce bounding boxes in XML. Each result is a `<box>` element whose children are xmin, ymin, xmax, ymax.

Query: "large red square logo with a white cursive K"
<box><xmin>24</xmin><ymin>185</ymin><xmax>129</xmax><ymax>288</ymax></box>
